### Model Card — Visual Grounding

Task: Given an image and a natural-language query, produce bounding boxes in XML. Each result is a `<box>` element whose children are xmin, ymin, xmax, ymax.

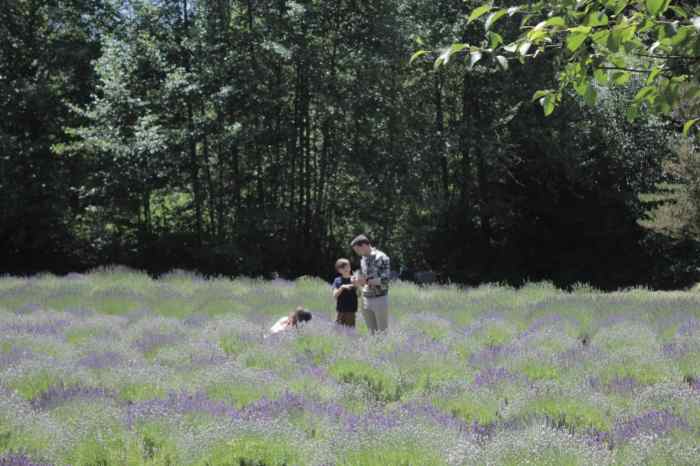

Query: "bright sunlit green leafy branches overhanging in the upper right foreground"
<box><xmin>426</xmin><ymin>0</ymin><xmax>700</xmax><ymax>133</ymax></box>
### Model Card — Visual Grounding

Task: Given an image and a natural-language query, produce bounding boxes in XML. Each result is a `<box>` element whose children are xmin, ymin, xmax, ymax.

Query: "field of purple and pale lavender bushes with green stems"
<box><xmin>0</xmin><ymin>269</ymin><xmax>700</xmax><ymax>466</ymax></box>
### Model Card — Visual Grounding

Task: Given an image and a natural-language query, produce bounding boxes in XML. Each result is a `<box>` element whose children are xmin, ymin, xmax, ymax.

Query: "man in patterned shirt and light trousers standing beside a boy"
<box><xmin>350</xmin><ymin>235</ymin><xmax>391</xmax><ymax>334</ymax></box>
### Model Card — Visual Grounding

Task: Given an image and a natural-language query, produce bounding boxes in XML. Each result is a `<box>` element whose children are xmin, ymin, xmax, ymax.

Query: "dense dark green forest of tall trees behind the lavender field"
<box><xmin>0</xmin><ymin>0</ymin><xmax>696</xmax><ymax>288</ymax></box>
